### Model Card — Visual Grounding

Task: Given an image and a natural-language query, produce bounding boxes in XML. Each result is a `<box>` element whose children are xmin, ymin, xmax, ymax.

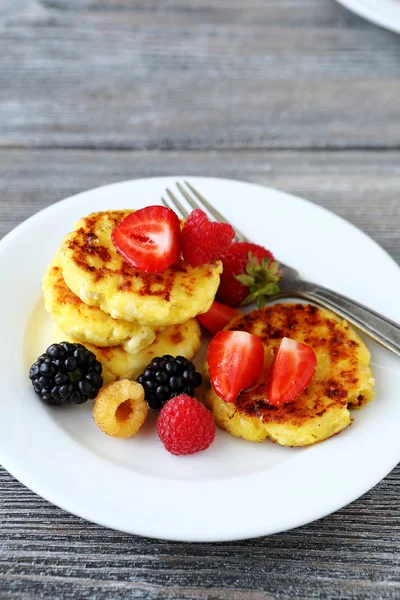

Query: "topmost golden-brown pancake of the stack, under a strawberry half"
<box><xmin>60</xmin><ymin>210</ymin><xmax>222</xmax><ymax>329</ymax></box>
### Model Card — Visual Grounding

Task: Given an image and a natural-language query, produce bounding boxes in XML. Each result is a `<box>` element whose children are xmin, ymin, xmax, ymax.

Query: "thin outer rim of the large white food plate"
<box><xmin>0</xmin><ymin>175</ymin><xmax>400</xmax><ymax>542</ymax></box>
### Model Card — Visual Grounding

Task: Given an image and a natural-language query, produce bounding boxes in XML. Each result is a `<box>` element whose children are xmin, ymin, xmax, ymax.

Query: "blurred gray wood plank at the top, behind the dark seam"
<box><xmin>0</xmin><ymin>0</ymin><xmax>400</xmax><ymax>150</ymax></box>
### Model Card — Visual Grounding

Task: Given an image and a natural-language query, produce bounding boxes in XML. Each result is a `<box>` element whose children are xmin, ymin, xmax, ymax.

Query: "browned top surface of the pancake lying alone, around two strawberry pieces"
<box><xmin>230</xmin><ymin>304</ymin><xmax>369</xmax><ymax>425</ymax></box>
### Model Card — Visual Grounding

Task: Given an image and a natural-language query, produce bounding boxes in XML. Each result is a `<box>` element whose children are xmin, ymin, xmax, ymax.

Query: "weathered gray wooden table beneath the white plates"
<box><xmin>0</xmin><ymin>0</ymin><xmax>400</xmax><ymax>600</ymax></box>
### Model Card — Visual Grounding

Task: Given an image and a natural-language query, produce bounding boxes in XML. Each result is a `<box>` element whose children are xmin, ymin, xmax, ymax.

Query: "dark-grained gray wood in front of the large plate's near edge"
<box><xmin>0</xmin><ymin>467</ymin><xmax>400</xmax><ymax>600</ymax></box>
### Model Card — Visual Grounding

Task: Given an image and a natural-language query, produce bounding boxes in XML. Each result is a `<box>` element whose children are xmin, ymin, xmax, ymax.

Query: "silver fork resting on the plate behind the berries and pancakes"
<box><xmin>161</xmin><ymin>181</ymin><xmax>400</xmax><ymax>356</ymax></box>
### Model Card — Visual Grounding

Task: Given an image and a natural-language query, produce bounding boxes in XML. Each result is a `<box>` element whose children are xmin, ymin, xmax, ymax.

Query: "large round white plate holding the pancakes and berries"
<box><xmin>0</xmin><ymin>177</ymin><xmax>400</xmax><ymax>541</ymax></box>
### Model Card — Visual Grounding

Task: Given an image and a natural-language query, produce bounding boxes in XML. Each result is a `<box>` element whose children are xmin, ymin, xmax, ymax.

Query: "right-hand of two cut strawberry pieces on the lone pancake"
<box><xmin>267</xmin><ymin>338</ymin><xmax>317</xmax><ymax>406</ymax></box>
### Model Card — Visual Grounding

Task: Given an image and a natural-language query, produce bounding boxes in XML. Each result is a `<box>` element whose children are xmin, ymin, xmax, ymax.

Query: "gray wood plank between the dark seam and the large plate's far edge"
<box><xmin>0</xmin><ymin>149</ymin><xmax>400</xmax><ymax>262</ymax></box>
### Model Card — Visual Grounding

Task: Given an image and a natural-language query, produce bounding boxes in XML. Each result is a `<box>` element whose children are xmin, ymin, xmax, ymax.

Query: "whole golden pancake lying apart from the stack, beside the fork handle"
<box><xmin>205</xmin><ymin>304</ymin><xmax>375</xmax><ymax>446</ymax></box>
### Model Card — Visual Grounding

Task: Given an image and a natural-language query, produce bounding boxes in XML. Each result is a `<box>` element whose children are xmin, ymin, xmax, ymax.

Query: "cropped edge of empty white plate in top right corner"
<box><xmin>337</xmin><ymin>0</ymin><xmax>400</xmax><ymax>33</ymax></box>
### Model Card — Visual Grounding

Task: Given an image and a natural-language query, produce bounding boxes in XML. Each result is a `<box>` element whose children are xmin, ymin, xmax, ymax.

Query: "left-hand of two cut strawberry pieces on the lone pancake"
<box><xmin>207</xmin><ymin>331</ymin><xmax>264</xmax><ymax>402</ymax></box>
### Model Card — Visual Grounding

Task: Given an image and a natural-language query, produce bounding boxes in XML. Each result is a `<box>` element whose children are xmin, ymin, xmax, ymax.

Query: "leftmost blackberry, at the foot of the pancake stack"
<box><xmin>29</xmin><ymin>342</ymin><xmax>103</xmax><ymax>406</ymax></box>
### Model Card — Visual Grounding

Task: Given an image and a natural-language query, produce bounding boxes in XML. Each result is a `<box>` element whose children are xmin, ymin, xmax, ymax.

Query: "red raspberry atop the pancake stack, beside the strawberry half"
<box><xmin>181</xmin><ymin>208</ymin><xmax>235</xmax><ymax>267</ymax></box>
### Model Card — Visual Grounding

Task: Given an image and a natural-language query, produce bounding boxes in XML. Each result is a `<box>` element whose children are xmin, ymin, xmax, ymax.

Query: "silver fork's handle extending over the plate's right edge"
<box><xmin>284</xmin><ymin>281</ymin><xmax>400</xmax><ymax>356</ymax></box>
